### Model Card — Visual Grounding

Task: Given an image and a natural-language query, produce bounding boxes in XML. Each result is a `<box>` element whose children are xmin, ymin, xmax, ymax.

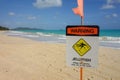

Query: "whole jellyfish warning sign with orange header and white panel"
<box><xmin>66</xmin><ymin>25</ymin><xmax>99</xmax><ymax>67</ymax></box>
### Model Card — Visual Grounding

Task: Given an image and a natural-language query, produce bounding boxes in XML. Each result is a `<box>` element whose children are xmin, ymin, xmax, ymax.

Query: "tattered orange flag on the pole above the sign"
<box><xmin>72</xmin><ymin>0</ymin><xmax>84</xmax><ymax>18</ymax></box>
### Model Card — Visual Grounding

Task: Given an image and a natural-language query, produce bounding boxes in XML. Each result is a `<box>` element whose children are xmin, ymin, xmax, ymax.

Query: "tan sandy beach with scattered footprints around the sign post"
<box><xmin>0</xmin><ymin>32</ymin><xmax>120</xmax><ymax>80</ymax></box>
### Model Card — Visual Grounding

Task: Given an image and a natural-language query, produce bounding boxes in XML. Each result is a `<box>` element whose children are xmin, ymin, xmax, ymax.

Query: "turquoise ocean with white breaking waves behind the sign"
<box><xmin>6</xmin><ymin>29</ymin><xmax>120</xmax><ymax>49</ymax></box>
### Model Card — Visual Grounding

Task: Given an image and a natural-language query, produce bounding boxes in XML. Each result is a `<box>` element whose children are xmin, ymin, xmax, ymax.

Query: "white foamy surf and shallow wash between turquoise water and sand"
<box><xmin>4</xmin><ymin>31</ymin><xmax>120</xmax><ymax>49</ymax></box>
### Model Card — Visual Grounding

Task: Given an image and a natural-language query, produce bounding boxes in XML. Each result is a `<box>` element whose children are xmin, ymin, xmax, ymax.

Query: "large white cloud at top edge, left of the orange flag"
<box><xmin>33</xmin><ymin>0</ymin><xmax>62</xmax><ymax>8</ymax></box>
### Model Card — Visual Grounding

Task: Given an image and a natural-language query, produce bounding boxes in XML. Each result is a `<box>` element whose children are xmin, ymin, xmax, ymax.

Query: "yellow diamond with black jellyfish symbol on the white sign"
<box><xmin>72</xmin><ymin>38</ymin><xmax>91</xmax><ymax>56</ymax></box>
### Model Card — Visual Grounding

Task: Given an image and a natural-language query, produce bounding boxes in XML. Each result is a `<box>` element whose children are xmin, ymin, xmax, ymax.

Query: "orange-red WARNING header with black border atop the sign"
<box><xmin>66</xmin><ymin>25</ymin><xmax>99</xmax><ymax>36</ymax></box>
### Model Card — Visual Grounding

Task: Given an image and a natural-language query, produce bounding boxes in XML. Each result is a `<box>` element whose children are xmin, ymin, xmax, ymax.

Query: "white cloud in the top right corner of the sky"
<box><xmin>101</xmin><ymin>0</ymin><xmax>120</xmax><ymax>9</ymax></box>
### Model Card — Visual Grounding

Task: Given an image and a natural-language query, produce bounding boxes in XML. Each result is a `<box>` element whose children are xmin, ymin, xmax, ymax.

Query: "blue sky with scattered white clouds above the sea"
<box><xmin>0</xmin><ymin>0</ymin><xmax>120</xmax><ymax>30</ymax></box>
